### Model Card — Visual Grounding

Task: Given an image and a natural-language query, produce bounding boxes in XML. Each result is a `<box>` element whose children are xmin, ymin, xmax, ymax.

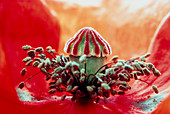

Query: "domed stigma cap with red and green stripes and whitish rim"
<box><xmin>64</xmin><ymin>27</ymin><xmax>112</xmax><ymax>57</ymax></box>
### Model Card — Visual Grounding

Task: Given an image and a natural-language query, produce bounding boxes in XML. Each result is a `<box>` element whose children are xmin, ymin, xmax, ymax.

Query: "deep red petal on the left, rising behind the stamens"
<box><xmin>0</xmin><ymin>0</ymin><xmax>60</xmax><ymax>99</ymax></box>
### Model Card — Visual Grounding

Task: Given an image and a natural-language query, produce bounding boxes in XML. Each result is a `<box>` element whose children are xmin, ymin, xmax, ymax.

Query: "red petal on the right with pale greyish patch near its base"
<box><xmin>101</xmin><ymin>13</ymin><xmax>170</xmax><ymax>113</ymax></box>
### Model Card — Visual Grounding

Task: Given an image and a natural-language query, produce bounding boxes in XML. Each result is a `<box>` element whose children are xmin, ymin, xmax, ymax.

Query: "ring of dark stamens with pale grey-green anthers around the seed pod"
<box><xmin>19</xmin><ymin>45</ymin><xmax>161</xmax><ymax>103</ymax></box>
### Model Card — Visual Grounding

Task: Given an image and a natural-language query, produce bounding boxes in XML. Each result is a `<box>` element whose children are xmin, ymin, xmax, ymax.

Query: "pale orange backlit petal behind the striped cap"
<box><xmin>46</xmin><ymin>0</ymin><xmax>170</xmax><ymax>59</ymax></box>
